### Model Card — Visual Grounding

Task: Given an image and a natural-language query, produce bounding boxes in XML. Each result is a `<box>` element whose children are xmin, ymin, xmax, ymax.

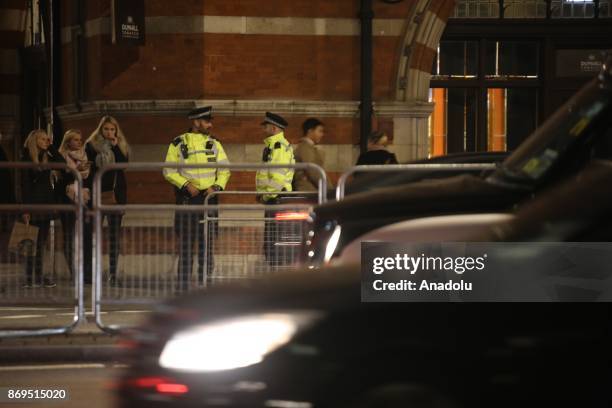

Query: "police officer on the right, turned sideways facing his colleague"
<box><xmin>255</xmin><ymin>112</ymin><xmax>295</xmax><ymax>266</ymax></box>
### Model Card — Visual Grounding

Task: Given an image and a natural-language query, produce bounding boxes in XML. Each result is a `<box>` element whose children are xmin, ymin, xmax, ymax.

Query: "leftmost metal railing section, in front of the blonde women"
<box><xmin>0</xmin><ymin>162</ymin><xmax>85</xmax><ymax>338</ymax></box>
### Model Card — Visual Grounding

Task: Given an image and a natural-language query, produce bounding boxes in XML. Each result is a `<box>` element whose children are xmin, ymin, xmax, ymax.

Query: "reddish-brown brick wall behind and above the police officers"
<box><xmin>55</xmin><ymin>0</ymin><xmax>448</xmax><ymax>202</ymax></box>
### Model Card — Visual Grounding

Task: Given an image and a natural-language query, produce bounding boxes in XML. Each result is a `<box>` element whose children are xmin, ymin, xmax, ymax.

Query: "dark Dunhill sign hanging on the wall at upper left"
<box><xmin>111</xmin><ymin>0</ymin><xmax>145</xmax><ymax>45</ymax></box>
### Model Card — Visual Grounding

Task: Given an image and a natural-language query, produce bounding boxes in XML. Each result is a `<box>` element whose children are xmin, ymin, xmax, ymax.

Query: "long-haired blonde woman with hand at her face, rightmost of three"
<box><xmin>85</xmin><ymin>116</ymin><xmax>130</xmax><ymax>286</ymax></box>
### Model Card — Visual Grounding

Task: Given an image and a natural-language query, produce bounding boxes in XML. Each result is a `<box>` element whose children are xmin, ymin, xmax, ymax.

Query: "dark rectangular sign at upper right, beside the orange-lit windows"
<box><xmin>555</xmin><ymin>49</ymin><xmax>611</xmax><ymax>78</ymax></box>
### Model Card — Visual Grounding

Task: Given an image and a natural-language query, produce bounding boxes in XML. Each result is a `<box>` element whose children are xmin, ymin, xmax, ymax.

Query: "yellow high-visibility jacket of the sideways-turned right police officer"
<box><xmin>255</xmin><ymin>132</ymin><xmax>295</xmax><ymax>201</ymax></box>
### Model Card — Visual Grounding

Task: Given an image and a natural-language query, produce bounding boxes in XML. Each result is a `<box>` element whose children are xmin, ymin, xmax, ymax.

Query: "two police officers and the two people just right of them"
<box><xmin>164</xmin><ymin>106</ymin><xmax>397</xmax><ymax>288</ymax></box>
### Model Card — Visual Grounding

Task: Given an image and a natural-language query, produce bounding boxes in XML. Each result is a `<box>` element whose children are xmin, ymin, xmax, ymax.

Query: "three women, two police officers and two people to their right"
<box><xmin>16</xmin><ymin>106</ymin><xmax>397</xmax><ymax>289</ymax></box>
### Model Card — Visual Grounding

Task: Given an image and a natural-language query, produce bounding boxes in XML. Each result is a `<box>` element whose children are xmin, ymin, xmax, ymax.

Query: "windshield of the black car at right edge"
<box><xmin>496</xmin><ymin>79</ymin><xmax>611</xmax><ymax>184</ymax></box>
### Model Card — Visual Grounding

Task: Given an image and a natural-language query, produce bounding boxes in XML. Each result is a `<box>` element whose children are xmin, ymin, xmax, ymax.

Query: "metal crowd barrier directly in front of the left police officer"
<box><xmin>93</xmin><ymin>162</ymin><xmax>327</xmax><ymax>332</ymax></box>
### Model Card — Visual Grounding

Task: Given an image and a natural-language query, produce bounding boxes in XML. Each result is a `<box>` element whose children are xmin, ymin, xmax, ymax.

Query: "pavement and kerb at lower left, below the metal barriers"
<box><xmin>0</xmin><ymin>282</ymin><xmax>154</xmax><ymax>365</ymax></box>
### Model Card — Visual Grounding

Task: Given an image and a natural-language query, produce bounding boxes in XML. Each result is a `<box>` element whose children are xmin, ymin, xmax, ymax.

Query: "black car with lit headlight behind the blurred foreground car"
<box><xmin>303</xmin><ymin>59</ymin><xmax>612</xmax><ymax>267</ymax></box>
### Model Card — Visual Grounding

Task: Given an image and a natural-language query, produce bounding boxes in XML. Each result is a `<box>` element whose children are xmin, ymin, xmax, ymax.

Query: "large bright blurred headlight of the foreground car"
<box><xmin>159</xmin><ymin>312</ymin><xmax>318</xmax><ymax>372</ymax></box>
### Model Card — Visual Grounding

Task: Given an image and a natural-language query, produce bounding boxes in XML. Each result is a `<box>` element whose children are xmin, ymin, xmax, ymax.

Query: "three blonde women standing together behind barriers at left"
<box><xmin>21</xmin><ymin>116</ymin><xmax>130</xmax><ymax>288</ymax></box>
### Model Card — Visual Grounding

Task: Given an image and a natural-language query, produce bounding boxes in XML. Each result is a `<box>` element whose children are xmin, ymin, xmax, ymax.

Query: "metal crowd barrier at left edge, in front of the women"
<box><xmin>0</xmin><ymin>162</ymin><xmax>85</xmax><ymax>338</ymax></box>
